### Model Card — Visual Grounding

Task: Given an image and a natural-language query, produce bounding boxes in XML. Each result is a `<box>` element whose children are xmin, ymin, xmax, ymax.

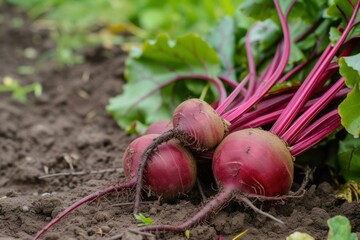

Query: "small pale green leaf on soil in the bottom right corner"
<box><xmin>327</xmin><ymin>215</ymin><xmax>357</xmax><ymax>240</ymax></box>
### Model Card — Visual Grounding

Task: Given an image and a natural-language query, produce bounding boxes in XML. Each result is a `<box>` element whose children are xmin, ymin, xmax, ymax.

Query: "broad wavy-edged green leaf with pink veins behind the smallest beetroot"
<box><xmin>107</xmin><ymin>34</ymin><xmax>220</xmax><ymax>133</ymax></box>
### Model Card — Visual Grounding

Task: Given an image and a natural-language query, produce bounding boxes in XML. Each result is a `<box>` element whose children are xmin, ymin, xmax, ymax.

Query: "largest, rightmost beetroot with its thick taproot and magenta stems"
<box><xmin>129</xmin><ymin>0</ymin><xmax>360</xmax><ymax>236</ymax></box>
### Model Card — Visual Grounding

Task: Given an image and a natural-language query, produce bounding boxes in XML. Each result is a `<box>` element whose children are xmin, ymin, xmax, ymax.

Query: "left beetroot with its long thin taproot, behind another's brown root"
<box><xmin>34</xmin><ymin>134</ymin><xmax>196</xmax><ymax>239</ymax></box>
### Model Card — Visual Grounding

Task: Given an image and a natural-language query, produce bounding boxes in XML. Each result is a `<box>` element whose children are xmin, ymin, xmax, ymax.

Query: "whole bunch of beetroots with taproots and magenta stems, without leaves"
<box><xmin>35</xmin><ymin>0</ymin><xmax>359</xmax><ymax>239</ymax></box>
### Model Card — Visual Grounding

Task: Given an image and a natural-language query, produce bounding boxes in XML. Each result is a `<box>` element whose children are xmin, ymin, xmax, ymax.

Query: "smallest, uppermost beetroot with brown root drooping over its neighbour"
<box><xmin>134</xmin><ymin>99</ymin><xmax>228</xmax><ymax>213</ymax></box>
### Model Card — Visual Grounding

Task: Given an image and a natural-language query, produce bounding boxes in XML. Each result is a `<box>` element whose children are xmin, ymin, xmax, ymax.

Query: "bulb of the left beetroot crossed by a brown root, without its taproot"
<box><xmin>123</xmin><ymin>134</ymin><xmax>196</xmax><ymax>199</ymax></box>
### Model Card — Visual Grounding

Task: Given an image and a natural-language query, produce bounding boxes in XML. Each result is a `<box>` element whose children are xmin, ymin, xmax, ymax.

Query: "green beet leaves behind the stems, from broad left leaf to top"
<box><xmin>108</xmin><ymin>0</ymin><xmax>342</xmax><ymax>133</ymax></box>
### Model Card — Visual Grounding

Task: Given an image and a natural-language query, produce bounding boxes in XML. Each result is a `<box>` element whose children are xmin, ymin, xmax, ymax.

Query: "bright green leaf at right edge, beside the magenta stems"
<box><xmin>339</xmin><ymin>54</ymin><xmax>360</xmax><ymax>138</ymax></box>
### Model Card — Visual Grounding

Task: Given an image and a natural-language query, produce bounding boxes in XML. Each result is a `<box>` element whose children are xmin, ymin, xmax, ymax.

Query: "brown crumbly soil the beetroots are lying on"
<box><xmin>0</xmin><ymin>6</ymin><xmax>360</xmax><ymax>240</ymax></box>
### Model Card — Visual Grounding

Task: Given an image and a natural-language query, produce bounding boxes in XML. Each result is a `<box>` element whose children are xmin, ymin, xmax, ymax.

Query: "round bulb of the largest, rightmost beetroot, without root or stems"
<box><xmin>213</xmin><ymin>129</ymin><xmax>294</xmax><ymax>196</ymax></box>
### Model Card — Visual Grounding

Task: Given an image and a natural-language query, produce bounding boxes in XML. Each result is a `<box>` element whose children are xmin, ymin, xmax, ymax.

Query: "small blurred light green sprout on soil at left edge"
<box><xmin>0</xmin><ymin>77</ymin><xmax>42</xmax><ymax>103</ymax></box>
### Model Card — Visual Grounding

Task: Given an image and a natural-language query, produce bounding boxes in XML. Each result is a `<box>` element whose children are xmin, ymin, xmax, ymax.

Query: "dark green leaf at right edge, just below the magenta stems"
<box><xmin>338</xmin><ymin>135</ymin><xmax>360</xmax><ymax>182</ymax></box>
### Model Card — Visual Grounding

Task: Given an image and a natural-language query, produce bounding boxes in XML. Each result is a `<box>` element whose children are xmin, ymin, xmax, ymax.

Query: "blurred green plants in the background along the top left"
<box><xmin>0</xmin><ymin>0</ymin><xmax>242</xmax><ymax>65</ymax></box>
